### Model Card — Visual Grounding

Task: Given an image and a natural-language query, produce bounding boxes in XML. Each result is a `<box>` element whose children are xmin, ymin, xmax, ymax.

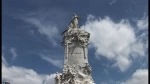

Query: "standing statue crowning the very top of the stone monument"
<box><xmin>70</xmin><ymin>13</ymin><xmax>81</xmax><ymax>28</ymax></box>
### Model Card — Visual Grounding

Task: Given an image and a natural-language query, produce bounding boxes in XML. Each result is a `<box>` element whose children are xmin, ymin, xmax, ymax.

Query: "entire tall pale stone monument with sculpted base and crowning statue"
<box><xmin>55</xmin><ymin>13</ymin><xmax>95</xmax><ymax>84</ymax></box>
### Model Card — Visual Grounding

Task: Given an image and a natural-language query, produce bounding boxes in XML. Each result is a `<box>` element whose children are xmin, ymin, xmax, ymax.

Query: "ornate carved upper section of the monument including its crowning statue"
<box><xmin>62</xmin><ymin>13</ymin><xmax>89</xmax><ymax>47</ymax></box>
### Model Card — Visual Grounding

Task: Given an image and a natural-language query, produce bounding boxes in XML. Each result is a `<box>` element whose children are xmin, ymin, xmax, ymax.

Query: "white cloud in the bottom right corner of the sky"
<box><xmin>121</xmin><ymin>69</ymin><xmax>148</xmax><ymax>84</ymax></box>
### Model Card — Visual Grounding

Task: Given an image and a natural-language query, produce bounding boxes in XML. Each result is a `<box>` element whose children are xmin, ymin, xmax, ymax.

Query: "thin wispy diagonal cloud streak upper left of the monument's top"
<box><xmin>22</xmin><ymin>17</ymin><xmax>58</xmax><ymax>45</ymax></box>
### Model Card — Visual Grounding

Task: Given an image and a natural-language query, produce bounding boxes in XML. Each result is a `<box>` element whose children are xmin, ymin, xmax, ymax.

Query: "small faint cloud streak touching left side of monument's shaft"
<box><xmin>41</xmin><ymin>54</ymin><xmax>63</xmax><ymax>68</ymax></box>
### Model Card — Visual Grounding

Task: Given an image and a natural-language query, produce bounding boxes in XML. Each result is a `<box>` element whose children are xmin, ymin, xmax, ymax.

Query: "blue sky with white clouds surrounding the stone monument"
<box><xmin>1</xmin><ymin>0</ymin><xmax>148</xmax><ymax>84</ymax></box>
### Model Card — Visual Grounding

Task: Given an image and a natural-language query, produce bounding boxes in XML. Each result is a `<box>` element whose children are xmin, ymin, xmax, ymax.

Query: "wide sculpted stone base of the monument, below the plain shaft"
<box><xmin>55</xmin><ymin>64</ymin><xmax>95</xmax><ymax>84</ymax></box>
